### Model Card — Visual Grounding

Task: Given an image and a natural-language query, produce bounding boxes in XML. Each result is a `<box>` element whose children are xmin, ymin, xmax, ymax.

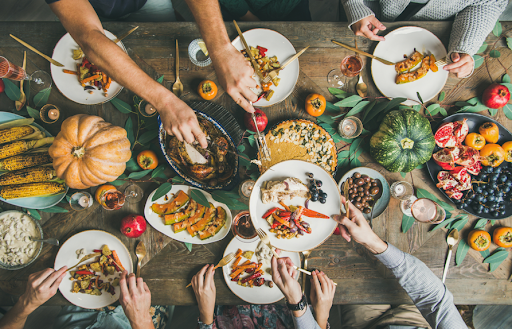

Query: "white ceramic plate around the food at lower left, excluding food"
<box><xmin>54</xmin><ymin>230</ymin><xmax>133</xmax><ymax>308</ymax></box>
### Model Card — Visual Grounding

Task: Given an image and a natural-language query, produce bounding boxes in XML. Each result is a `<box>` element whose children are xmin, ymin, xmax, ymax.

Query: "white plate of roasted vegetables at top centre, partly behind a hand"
<box><xmin>232</xmin><ymin>29</ymin><xmax>299</xmax><ymax>107</ymax></box>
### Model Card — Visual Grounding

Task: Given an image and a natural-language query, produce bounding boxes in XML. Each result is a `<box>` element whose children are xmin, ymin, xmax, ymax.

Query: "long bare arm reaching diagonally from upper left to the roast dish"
<box><xmin>50</xmin><ymin>0</ymin><xmax>207</xmax><ymax>147</ymax></box>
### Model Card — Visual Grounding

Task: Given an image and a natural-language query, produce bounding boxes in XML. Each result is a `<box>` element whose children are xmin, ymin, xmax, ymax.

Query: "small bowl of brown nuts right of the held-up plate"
<box><xmin>338</xmin><ymin>167</ymin><xmax>390</xmax><ymax>220</ymax></box>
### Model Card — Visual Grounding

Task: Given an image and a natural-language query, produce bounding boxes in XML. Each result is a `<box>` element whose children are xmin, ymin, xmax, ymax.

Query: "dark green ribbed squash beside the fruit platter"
<box><xmin>370</xmin><ymin>109</ymin><xmax>435</xmax><ymax>172</ymax></box>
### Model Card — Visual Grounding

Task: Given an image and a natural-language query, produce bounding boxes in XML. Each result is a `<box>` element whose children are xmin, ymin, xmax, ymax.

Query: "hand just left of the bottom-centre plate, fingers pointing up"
<box><xmin>192</xmin><ymin>264</ymin><xmax>216</xmax><ymax>325</ymax></box>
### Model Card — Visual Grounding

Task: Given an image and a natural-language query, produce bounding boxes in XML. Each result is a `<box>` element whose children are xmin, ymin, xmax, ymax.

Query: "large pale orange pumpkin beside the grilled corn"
<box><xmin>48</xmin><ymin>114</ymin><xmax>132</xmax><ymax>189</ymax></box>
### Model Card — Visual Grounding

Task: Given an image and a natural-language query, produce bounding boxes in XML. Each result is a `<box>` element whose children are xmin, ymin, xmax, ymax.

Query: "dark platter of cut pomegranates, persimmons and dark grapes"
<box><xmin>427</xmin><ymin>113</ymin><xmax>512</xmax><ymax>219</ymax></box>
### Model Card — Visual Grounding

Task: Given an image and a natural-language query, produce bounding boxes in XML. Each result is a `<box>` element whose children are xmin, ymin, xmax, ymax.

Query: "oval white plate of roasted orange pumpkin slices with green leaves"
<box><xmin>144</xmin><ymin>185</ymin><xmax>232</xmax><ymax>244</ymax></box>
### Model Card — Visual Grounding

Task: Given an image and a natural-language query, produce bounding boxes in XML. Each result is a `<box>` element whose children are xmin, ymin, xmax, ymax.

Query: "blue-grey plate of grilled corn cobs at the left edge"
<box><xmin>0</xmin><ymin>112</ymin><xmax>68</xmax><ymax>209</ymax></box>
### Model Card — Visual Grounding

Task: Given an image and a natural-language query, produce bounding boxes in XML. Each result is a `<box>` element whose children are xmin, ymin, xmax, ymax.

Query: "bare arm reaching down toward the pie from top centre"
<box><xmin>186</xmin><ymin>0</ymin><xmax>258</xmax><ymax>113</ymax></box>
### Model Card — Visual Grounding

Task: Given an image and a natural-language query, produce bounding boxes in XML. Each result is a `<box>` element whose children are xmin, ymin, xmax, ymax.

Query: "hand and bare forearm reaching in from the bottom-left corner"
<box><xmin>0</xmin><ymin>266</ymin><xmax>67</xmax><ymax>329</ymax></box>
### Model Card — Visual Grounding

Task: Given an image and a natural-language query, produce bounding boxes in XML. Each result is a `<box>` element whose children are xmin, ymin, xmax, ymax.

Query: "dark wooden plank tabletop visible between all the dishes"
<box><xmin>0</xmin><ymin>22</ymin><xmax>512</xmax><ymax>305</ymax></box>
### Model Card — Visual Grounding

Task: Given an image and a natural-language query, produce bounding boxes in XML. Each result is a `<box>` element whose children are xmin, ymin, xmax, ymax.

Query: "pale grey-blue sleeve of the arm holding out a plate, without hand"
<box><xmin>375</xmin><ymin>245</ymin><xmax>465</xmax><ymax>328</ymax></box>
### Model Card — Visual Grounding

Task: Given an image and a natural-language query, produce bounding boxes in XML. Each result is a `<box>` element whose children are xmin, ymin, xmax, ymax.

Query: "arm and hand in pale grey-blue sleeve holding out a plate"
<box><xmin>335</xmin><ymin>197</ymin><xmax>465</xmax><ymax>328</ymax></box>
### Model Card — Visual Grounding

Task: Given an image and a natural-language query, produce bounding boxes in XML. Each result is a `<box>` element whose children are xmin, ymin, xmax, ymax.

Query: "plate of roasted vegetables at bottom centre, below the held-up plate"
<box><xmin>222</xmin><ymin>238</ymin><xmax>300</xmax><ymax>304</ymax></box>
